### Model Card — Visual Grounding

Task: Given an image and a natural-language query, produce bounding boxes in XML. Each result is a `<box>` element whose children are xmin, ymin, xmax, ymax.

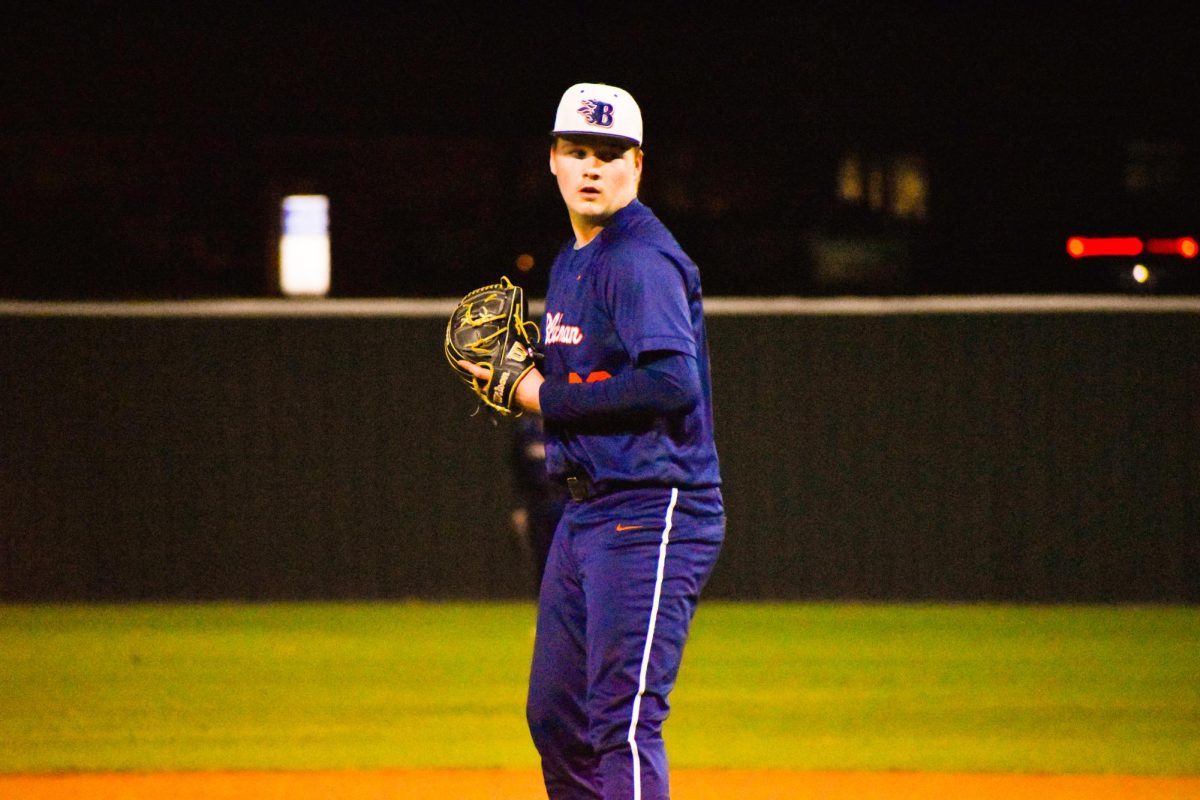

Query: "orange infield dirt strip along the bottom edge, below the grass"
<box><xmin>0</xmin><ymin>770</ymin><xmax>1200</xmax><ymax>800</ymax></box>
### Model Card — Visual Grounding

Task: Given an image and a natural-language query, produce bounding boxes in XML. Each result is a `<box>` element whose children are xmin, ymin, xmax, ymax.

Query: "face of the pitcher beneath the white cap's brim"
<box><xmin>550</xmin><ymin>136</ymin><xmax>642</xmax><ymax>231</ymax></box>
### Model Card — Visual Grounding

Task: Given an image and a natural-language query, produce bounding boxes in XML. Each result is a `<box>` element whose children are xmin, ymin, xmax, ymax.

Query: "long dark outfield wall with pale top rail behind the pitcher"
<box><xmin>0</xmin><ymin>297</ymin><xmax>1200</xmax><ymax>602</ymax></box>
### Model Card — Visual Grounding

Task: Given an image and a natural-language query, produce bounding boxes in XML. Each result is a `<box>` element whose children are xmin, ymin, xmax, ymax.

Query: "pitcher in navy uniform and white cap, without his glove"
<box><xmin>487</xmin><ymin>84</ymin><xmax>725</xmax><ymax>800</ymax></box>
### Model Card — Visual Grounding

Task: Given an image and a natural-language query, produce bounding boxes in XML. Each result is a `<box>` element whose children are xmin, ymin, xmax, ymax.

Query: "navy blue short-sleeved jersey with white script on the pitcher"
<box><xmin>542</xmin><ymin>200</ymin><xmax>721</xmax><ymax>489</ymax></box>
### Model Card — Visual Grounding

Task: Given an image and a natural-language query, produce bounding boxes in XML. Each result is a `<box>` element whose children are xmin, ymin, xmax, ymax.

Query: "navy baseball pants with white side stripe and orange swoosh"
<box><xmin>527</xmin><ymin>488</ymin><xmax>725</xmax><ymax>800</ymax></box>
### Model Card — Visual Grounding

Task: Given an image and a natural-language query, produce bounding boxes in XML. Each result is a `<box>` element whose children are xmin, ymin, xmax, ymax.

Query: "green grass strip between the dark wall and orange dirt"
<box><xmin>0</xmin><ymin>602</ymin><xmax>1200</xmax><ymax>775</ymax></box>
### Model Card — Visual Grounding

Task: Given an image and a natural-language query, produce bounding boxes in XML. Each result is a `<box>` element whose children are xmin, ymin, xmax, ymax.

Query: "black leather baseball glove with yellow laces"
<box><xmin>444</xmin><ymin>277</ymin><xmax>539</xmax><ymax>416</ymax></box>
